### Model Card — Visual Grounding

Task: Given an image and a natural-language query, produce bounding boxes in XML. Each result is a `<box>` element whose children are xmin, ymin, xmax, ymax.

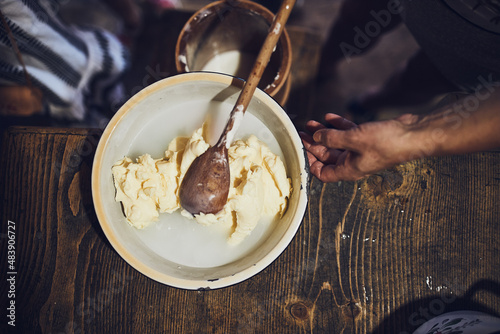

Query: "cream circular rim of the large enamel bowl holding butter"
<box><xmin>91</xmin><ymin>72</ymin><xmax>309</xmax><ymax>290</ymax></box>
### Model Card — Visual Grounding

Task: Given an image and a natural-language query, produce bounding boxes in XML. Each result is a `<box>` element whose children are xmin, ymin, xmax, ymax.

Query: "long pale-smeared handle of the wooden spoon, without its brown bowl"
<box><xmin>217</xmin><ymin>0</ymin><xmax>296</xmax><ymax>147</ymax></box>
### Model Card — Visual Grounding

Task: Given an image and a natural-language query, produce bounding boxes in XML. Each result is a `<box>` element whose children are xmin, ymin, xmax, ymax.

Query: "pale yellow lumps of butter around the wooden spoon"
<box><xmin>112</xmin><ymin>127</ymin><xmax>291</xmax><ymax>245</ymax></box>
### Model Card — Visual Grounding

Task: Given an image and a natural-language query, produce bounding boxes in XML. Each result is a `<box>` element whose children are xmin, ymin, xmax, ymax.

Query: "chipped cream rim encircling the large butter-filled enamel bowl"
<box><xmin>92</xmin><ymin>72</ymin><xmax>309</xmax><ymax>290</ymax></box>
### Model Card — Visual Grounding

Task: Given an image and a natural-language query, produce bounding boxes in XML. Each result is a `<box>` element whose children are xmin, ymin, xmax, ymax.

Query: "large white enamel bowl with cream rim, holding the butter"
<box><xmin>92</xmin><ymin>72</ymin><xmax>309</xmax><ymax>290</ymax></box>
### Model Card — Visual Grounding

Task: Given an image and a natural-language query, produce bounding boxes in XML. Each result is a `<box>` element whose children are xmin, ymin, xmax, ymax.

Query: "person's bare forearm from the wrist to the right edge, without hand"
<box><xmin>405</xmin><ymin>87</ymin><xmax>500</xmax><ymax>160</ymax></box>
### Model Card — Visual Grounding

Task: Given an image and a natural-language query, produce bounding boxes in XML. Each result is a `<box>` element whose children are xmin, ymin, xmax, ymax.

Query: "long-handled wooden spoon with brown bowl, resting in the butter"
<box><xmin>179</xmin><ymin>0</ymin><xmax>295</xmax><ymax>215</ymax></box>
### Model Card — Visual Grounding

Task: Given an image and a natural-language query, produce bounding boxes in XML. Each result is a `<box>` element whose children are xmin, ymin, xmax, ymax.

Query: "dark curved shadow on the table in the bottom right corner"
<box><xmin>373</xmin><ymin>279</ymin><xmax>500</xmax><ymax>334</ymax></box>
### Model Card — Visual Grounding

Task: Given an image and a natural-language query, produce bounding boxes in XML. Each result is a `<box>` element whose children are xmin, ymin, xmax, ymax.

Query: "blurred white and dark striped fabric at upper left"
<box><xmin>0</xmin><ymin>0</ymin><xmax>128</xmax><ymax>121</ymax></box>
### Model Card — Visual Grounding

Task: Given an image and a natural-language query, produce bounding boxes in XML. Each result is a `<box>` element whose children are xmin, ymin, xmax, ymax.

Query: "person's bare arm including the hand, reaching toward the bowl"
<box><xmin>301</xmin><ymin>88</ymin><xmax>500</xmax><ymax>182</ymax></box>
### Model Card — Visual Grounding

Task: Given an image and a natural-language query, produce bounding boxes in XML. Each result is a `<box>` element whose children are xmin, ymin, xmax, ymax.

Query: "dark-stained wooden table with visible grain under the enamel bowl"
<box><xmin>0</xmin><ymin>8</ymin><xmax>500</xmax><ymax>333</ymax></box>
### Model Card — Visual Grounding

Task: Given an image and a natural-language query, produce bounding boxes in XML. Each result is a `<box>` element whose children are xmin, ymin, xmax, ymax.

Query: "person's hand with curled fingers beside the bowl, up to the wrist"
<box><xmin>300</xmin><ymin>114</ymin><xmax>417</xmax><ymax>182</ymax></box>
